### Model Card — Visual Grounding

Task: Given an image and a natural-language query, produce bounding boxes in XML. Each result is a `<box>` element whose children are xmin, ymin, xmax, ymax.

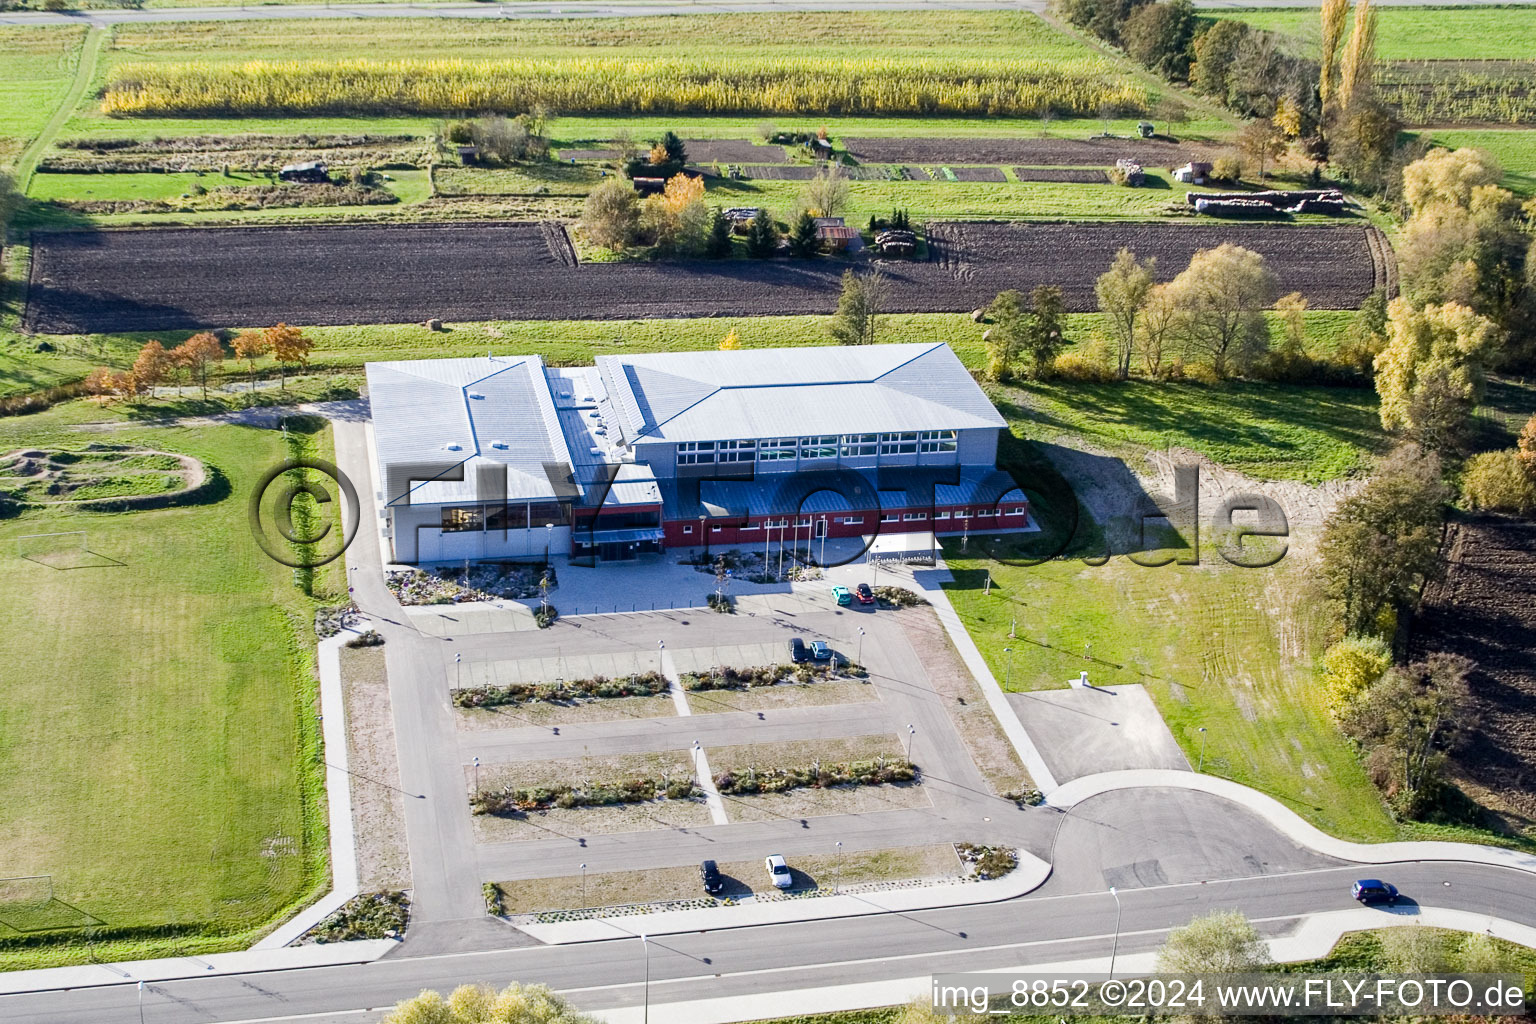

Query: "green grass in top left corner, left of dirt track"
<box><xmin>0</xmin><ymin>26</ymin><xmax>86</xmax><ymax>167</ymax></box>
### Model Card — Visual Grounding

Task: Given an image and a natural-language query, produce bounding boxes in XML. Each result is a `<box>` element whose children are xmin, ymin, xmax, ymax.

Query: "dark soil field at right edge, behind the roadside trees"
<box><xmin>1413</xmin><ymin>519</ymin><xmax>1536</xmax><ymax>821</ymax></box>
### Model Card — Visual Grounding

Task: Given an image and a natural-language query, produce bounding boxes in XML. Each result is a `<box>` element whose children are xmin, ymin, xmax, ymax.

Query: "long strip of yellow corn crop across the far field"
<box><xmin>101</xmin><ymin>58</ymin><xmax>1149</xmax><ymax>117</ymax></box>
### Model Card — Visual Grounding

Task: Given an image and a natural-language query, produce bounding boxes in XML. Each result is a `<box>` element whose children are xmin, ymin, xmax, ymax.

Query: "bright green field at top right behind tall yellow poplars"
<box><xmin>1201</xmin><ymin>5</ymin><xmax>1536</xmax><ymax>60</ymax></box>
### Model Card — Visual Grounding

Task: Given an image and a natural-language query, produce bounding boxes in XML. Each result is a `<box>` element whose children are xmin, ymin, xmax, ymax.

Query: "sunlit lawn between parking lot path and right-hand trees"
<box><xmin>945</xmin><ymin>528</ymin><xmax>1396</xmax><ymax>841</ymax></box>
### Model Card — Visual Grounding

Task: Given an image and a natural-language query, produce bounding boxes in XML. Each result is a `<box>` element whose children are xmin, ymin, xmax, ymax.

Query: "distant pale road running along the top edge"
<box><xmin>0</xmin><ymin>0</ymin><xmax>1536</xmax><ymax>25</ymax></box>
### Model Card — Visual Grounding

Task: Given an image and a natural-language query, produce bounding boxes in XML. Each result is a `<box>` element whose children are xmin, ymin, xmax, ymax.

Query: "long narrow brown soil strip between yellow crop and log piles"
<box><xmin>841</xmin><ymin>138</ymin><xmax>1207</xmax><ymax>167</ymax></box>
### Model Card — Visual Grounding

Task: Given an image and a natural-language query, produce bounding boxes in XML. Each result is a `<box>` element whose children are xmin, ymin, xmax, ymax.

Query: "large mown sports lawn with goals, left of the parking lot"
<box><xmin>0</xmin><ymin>402</ymin><xmax>339</xmax><ymax>969</ymax></box>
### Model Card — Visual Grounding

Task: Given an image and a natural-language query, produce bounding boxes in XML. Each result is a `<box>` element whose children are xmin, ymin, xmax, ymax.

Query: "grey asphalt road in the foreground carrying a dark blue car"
<box><xmin>0</xmin><ymin>859</ymin><xmax>1536</xmax><ymax>1024</ymax></box>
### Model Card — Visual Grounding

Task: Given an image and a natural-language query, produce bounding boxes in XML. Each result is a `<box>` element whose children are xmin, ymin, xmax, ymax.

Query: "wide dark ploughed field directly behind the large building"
<box><xmin>25</xmin><ymin>223</ymin><xmax>1379</xmax><ymax>333</ymax></box>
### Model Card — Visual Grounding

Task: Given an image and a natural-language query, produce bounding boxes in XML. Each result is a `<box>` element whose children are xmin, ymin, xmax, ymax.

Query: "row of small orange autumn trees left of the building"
<box><xmin>84</xmin><ymin>324</ymin><xmax>315</xmax><ymax>399</ymax></box>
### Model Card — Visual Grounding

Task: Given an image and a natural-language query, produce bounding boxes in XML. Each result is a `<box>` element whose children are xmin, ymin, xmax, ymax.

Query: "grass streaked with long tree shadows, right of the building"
<box><xmin>994</xmin><ymin>381</ymin><xmax>1387</xmax><ymax>484</ymax></box>
